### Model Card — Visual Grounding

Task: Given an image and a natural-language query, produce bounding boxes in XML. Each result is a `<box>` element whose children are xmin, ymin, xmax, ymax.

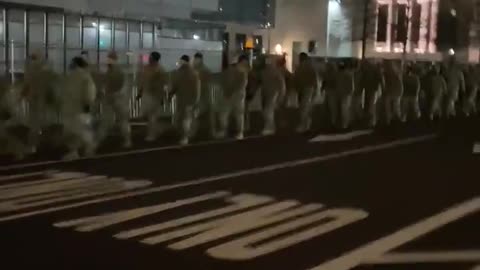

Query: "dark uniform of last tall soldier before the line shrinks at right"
<box><xmin>294</xmin><ymin>60</ymin><xmax>318</xmax><ymax>132</ymax></box>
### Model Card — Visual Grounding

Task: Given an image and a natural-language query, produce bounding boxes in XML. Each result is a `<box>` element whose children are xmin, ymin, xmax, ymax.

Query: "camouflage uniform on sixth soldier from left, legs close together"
<box><xmin>172</xmin><ymin>64</ymin><xmax>201</xmax><ymax>144</ymax></box>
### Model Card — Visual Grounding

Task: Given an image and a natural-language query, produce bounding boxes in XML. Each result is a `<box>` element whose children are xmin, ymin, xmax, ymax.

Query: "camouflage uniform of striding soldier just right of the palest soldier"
<box><xmin>98</xmin><ymin>64</ymin><xmax>131</xmax><ymax>147</ymax></box>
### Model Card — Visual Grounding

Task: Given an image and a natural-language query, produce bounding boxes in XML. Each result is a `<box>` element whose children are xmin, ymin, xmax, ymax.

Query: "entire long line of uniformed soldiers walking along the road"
<box><xmin>0</xmin><ymin>49</ymin><xmax>479</xmax><ymax>159</ymax></box>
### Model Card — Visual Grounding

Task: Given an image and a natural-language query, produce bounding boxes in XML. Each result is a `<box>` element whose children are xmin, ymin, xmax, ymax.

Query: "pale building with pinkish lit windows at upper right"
<box><xmin>270</xmin><ymin>0</ymin><xmax>480</xmax><ymax>66</ymax></box>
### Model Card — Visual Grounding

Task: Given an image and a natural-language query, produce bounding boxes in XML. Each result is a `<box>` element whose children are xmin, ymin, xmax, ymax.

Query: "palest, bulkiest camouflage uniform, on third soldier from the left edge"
<box><xmin>62</xmin><ymin>68</ymin><xmax>97</xmax><ymax>159</ymax></box>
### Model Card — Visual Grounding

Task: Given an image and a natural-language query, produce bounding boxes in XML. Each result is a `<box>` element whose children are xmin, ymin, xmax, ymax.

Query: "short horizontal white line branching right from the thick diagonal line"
<box><xmin>366</xmin><ymin>250</ymin><xmax>480</xmax><ymax>264</ymax></box>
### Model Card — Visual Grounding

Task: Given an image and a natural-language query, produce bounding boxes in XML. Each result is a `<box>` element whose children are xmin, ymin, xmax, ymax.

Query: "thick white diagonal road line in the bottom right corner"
<box><xmin>310</xmin><ymin>197</ymin><xmax>480</xmax><ymax>270</ymax></box>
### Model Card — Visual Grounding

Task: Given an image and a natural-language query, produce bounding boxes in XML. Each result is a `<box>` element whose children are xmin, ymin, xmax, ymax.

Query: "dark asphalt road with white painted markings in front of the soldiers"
<box><xmin>0</xmin><ymin>116</ymin><xmax>480</xmax><ymax>270</ymax></box>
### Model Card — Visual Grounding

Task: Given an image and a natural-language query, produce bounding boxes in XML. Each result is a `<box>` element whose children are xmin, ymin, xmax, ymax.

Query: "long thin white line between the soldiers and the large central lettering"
<box><xmin>0</xmin><ymin>134</ymin><xmax>437</xmax><ymax>222</ymax></box>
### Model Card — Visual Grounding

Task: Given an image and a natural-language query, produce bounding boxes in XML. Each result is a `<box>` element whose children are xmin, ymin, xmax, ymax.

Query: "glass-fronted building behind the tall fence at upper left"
<box><xmin>0</xmin><ymin>0</ymin><xmax>225</xmax><ymax>74</ymax></box>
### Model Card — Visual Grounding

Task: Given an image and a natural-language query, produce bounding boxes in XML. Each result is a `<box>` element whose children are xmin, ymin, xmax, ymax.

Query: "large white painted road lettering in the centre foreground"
<box><xmin>54</xmin><ymin>191</ymin><xmax>368</xmax><ymax>260</ymax></box>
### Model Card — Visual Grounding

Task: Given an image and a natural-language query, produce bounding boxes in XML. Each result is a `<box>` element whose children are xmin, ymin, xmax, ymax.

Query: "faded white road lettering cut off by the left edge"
<box><xmin>0</xmin><ymin>171</ymin><xmax>152</xmax><ymax>222</ymax></box>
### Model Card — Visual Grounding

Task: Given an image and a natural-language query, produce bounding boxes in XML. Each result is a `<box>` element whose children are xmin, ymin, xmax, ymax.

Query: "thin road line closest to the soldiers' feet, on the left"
<box><xmin>0</xmin><ymin>136</ymin><xmax>266</xmax><ymax>171</ymax></box>
